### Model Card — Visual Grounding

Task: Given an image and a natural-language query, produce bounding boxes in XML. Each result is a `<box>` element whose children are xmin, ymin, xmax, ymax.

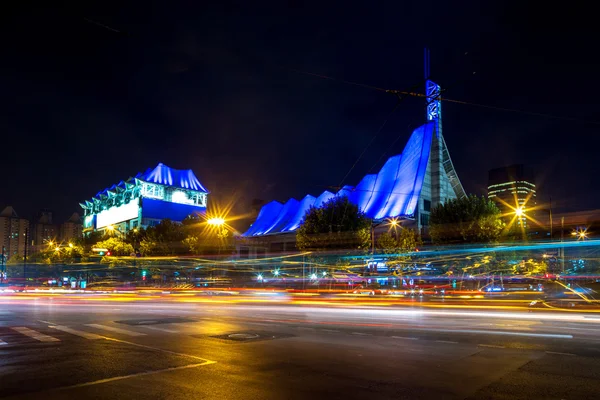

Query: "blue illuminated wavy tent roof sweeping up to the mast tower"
<box><xmin>243</xmin><ymin>122</ymin><xmax>434</xmax><ymax>236</ymax></box>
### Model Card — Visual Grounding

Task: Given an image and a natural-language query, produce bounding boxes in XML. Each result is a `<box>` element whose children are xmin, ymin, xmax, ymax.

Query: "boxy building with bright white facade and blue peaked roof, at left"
<box><xmin>80</xmin><ymin>163</ymin><xmax>208</xmax><ymax>233</ymax></box>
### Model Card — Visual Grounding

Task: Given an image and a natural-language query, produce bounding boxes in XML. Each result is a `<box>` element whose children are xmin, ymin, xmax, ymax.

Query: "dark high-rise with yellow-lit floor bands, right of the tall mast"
<box><xmin>488</xmin><ymin>164</ymin><xmax>536</xmax><ymax>228</ymax></box>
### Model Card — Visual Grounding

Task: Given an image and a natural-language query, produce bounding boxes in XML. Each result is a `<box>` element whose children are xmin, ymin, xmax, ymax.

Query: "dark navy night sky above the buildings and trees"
<box><xmin>0</xmin><ymin>0</ymin><xmax>600</xmax><ymax>227</ymax></box>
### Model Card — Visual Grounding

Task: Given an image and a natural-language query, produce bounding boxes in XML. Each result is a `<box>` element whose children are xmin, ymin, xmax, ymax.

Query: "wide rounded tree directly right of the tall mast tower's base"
<box><xmin>429</xmin><ymin>196</ymin><xmax>504</xmax><ymax>243</ymax></box>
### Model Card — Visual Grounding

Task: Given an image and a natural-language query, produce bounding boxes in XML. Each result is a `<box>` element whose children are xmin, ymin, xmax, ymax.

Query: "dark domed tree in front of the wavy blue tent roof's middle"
<box><xmin>296</xmin><ymin>196</ymin><xmax>372</xmax><ymax>250</ymax></box>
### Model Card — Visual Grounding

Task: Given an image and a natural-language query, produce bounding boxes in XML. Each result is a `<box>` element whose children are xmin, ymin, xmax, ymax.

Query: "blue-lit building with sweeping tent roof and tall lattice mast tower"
<box><xmin>242</xmin><ymin>76</ymin><xmax>465</xmax><ymax>242</ymax></box>
